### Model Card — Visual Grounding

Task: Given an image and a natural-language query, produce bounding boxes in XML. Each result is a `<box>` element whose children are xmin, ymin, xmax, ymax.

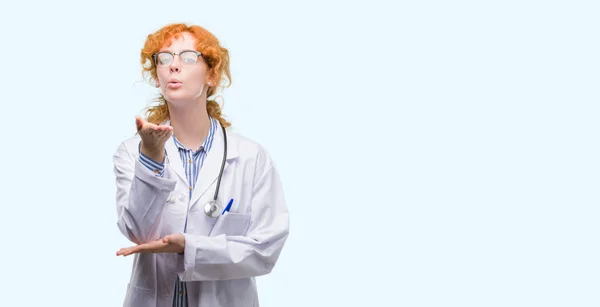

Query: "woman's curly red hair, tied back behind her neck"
<box><xmin>141</xmin><ymin>23</ymin><xmax>231</xmax><ymax>127</ymax></box>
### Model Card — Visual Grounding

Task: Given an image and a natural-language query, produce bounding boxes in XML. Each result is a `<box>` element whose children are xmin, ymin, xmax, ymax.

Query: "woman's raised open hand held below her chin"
<box><xmin>135</xmin><ymin>116</ymin><xmax>173</xmax><ymax>162</ymax></box>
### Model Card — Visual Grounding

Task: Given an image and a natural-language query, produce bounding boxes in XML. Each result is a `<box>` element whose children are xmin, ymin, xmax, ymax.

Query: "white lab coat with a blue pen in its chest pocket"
<box><xmin>114</xmin><ymin>122</ymin><xmax>289</xmax><ymax>307</ymax></box>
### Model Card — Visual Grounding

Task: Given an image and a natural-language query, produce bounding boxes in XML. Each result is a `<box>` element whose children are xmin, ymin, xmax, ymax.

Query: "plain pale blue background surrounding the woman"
<box><xmin>0</xmin><ymin>0</ymin><xmax>600</xmax><ymax>307</ymax></box>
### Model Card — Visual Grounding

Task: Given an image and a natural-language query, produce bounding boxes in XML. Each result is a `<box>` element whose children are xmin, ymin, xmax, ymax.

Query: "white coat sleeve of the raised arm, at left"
<box><xmin>113</xmin><ymin>143</ymin><xmax>177</xmax><ymax>244</ymax></box>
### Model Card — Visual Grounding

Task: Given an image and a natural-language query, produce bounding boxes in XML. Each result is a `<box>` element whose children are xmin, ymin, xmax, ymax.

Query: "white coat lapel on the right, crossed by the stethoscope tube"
<box><xmin>191</xmin><ymin>124</ymin><xmax>238</xmax><ymax>211</ymax></box>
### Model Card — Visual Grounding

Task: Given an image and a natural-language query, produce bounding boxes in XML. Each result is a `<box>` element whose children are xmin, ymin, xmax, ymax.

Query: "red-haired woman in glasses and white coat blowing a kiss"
<box><xmin>114</xmin><ymin>24</ymin><xmax>289</xmax><ymax>307</ymax></box>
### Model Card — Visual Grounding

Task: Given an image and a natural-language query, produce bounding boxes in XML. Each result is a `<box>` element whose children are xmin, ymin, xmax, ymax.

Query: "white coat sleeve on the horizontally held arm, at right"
<box><xmin>178</xmin><ymin>152</ymin><xmax>289</xmax><ymax>281</ymax></box>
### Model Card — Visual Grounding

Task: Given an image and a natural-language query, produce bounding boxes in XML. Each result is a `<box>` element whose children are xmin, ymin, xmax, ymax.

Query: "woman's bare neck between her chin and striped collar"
<box><xmin>169</xmin><ymin>102</ymin><xmax>210</xmax><ymax>150</ymax></box>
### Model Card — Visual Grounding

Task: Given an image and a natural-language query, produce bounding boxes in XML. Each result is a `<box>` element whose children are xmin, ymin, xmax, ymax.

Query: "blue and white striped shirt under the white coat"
<box><xmin>140</xmin><ymin>117</ymin><xmax>217</xmax><ymax>307</ymax></box>
